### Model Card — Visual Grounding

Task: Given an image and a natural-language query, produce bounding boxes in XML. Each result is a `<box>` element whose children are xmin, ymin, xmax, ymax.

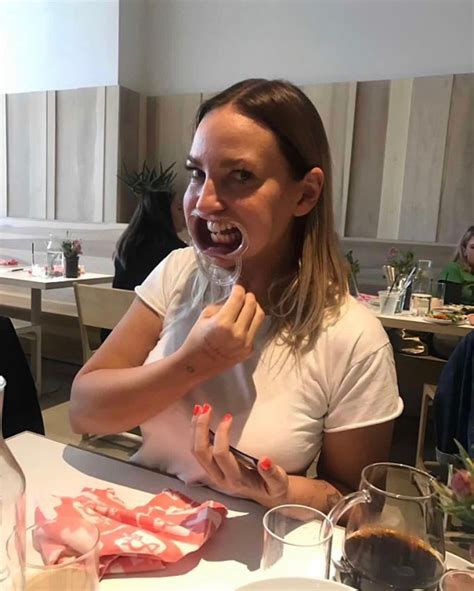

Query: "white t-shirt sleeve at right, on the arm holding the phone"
<box><xmin>324</xmin><ymin>343</ymin><xmax>403</xmax><ymax>432</ymax></box>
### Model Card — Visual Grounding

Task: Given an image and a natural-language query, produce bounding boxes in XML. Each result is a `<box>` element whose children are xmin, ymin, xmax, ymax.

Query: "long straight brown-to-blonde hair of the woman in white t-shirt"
<box><xmin>189</xmin><ymin>79</ymin><xmax>348</xmax><ymax>353</ymax></box>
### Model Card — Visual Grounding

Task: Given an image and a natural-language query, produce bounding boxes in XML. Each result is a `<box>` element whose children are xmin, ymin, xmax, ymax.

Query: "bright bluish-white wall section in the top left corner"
<box><xmin>0</xmin><ymin>0</ymin><xmax>119</xmax><ymax>94</ymax></box>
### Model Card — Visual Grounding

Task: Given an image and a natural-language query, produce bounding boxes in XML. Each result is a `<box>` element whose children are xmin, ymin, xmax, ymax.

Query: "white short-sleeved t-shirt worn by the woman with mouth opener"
<box><xmin>132</xmin><ymin>248</ymin><xmax>403</xmax><ymax>484</ymax></box>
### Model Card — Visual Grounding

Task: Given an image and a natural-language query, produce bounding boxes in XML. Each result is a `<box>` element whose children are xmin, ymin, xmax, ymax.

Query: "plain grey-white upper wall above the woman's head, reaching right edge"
<box><xmin>145</xmin><ymin>0</ymin><xmax>473</xmax><ymax>94</ymax></box>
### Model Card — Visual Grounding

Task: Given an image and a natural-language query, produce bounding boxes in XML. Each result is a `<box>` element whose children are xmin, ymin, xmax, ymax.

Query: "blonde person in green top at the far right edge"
<box><xmin>440</xmin><ymin>226</ymin><xmax>474</xmax><ymax>306</ymax></box>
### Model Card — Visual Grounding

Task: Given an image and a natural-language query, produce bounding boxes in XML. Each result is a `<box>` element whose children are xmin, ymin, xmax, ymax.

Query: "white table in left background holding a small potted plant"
<box><xmin>0</xmin><ymin>268</ymin><xmax>113</xmax><ymax>394</ymax></box>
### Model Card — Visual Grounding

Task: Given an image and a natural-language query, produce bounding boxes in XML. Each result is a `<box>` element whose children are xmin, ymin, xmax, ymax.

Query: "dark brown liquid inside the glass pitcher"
<box><xmin>344</xmin><ymin>527</ymin><xmax>444</xmax><ymax>591</ymax></box>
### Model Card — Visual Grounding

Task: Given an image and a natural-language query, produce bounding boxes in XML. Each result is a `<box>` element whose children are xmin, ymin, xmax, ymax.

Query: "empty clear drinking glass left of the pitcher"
<box><xmin>260</xmin><ymin>505</ymin><xmax>333</xmax><ymax>579</ymax></box>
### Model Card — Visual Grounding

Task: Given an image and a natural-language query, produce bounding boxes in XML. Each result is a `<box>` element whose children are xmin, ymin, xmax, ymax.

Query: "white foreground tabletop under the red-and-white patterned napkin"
<box><xmin>7</xmin><ymin>432</ymin><xmax>467</xmax><ymax>591</ymax></box>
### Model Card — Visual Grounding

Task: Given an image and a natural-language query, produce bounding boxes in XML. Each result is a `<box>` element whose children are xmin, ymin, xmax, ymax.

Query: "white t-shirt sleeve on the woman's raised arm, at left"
<box><xmin>135</xmin><ymin>249</ymin><xmax>189</xmax><ymax>318</ymax></box>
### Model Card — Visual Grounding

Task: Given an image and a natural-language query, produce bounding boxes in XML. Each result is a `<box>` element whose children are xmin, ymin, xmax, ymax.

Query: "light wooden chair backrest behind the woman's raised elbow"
<box><xmin>74</xmin><ymin>283</ymin><xmax>135</xmax><ymax>363</ymax></box>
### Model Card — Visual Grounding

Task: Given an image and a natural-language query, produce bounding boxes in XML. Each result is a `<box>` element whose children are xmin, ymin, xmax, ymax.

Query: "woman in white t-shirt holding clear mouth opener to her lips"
<box><xmin>71</xmin><ymin>79</ymin><xmax>402</xmax><ymax>511</ymax></box>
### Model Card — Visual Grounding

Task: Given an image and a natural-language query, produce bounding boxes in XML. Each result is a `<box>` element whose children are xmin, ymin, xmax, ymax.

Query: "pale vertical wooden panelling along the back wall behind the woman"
<box><xmin>0</xmin><ymin>74</ymin><xmax>474</xmax><ymax>244</ymax></box>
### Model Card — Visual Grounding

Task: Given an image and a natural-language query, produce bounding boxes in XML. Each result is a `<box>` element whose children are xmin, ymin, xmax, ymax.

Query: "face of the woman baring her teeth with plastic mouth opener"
<box><xmin>184</xmin><ymin>106</ymin><xmax>318</xmax><ymax>266</ymax></box>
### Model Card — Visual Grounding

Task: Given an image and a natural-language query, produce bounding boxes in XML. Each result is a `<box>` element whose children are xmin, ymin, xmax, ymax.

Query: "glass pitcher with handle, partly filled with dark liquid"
<box><xmin>329</xmin><ymin>463</ymin><xmax>445</xmax><ymax>591</ymax></box>
